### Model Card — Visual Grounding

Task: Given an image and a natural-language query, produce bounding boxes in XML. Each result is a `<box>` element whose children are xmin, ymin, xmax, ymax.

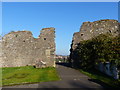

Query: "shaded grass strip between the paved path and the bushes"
<box><xmin>79</xmin><ymin>69</ymin><xmax>120</xmax><ymax>88</ymax></box>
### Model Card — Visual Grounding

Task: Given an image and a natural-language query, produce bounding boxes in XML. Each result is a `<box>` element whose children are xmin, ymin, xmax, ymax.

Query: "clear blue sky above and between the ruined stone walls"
<box><xmin>2</xmin><ymin>2</ymin><xmax>118</xmax><ymax>55</ymax></box>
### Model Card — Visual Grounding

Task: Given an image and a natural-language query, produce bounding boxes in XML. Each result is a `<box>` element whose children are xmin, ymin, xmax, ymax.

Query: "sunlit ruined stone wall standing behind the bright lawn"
<box><xmin>0</xmin><ymin>28</ymin><xmax>55</xmax><ymax>67</ymax></box>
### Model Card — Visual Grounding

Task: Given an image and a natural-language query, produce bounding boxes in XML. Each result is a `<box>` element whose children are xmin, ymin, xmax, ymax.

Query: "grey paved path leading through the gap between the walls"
<box><xmin>4</xmin><ymin>65</ymin><xmax>109</xmax><ymax>88</ymax></box>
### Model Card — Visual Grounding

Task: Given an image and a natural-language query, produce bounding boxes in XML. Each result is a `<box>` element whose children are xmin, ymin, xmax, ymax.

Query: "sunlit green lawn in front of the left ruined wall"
<box><xmin>2</xmin><ymin>66</ymin><xmax>60</xmax><ymax>86</ymax></box>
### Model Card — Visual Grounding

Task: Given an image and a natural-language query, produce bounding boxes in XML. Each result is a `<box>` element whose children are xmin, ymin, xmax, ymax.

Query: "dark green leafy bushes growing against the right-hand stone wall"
<box><xmin>73</xmin><ymin>34</ymin><xmax>120</xmax><ymax>69</ymax></box>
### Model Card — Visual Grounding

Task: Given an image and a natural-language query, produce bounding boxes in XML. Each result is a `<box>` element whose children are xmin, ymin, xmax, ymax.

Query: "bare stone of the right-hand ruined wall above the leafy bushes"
<box><xmin>70</xmin><ymin>19</ymin><xmax>120</xmax><ymax>54</ymax></box>
